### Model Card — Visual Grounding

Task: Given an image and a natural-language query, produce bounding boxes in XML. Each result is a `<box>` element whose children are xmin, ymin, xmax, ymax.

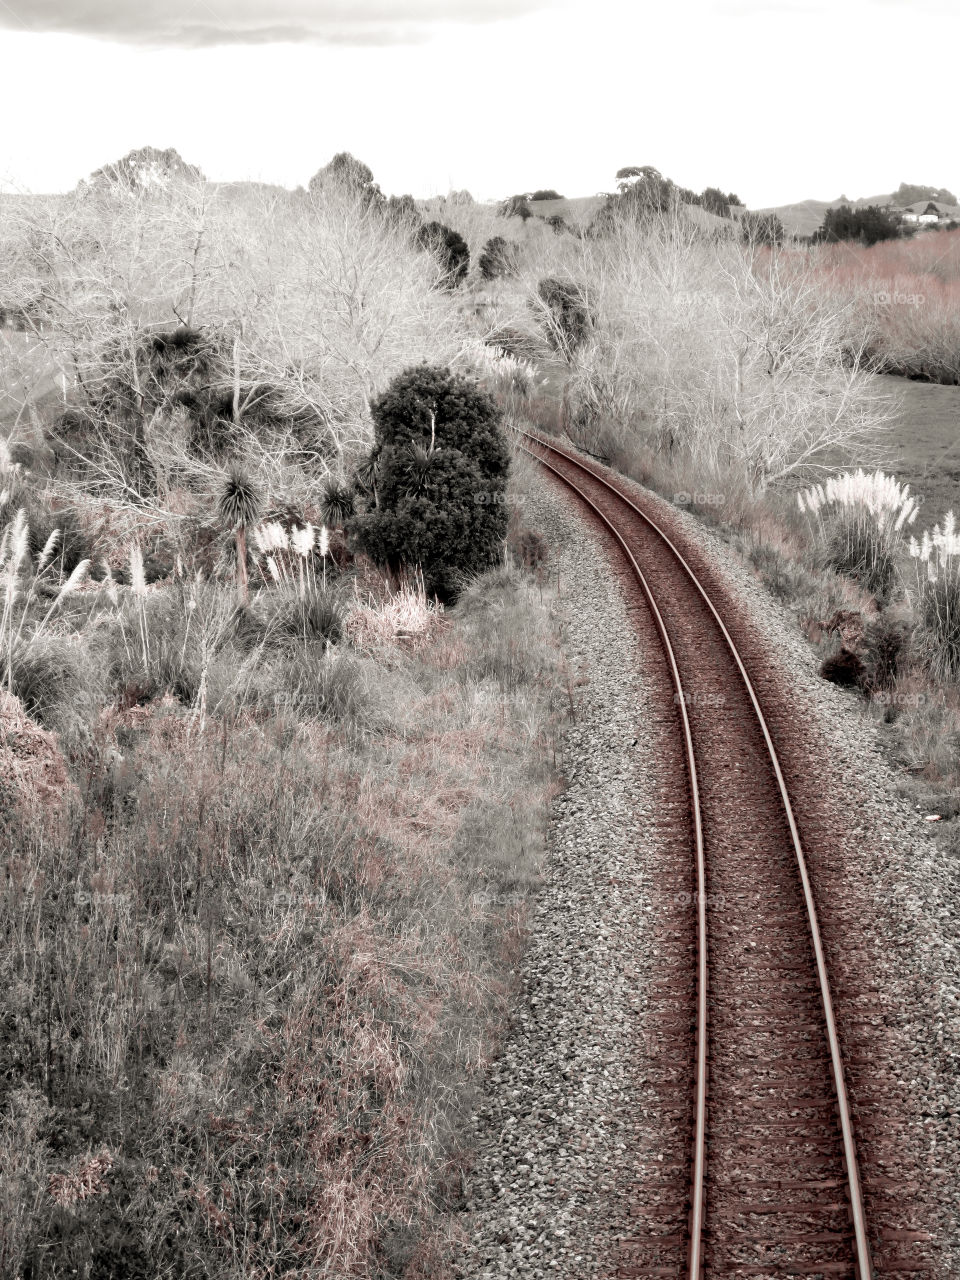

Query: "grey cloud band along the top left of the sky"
<box><xmin>0</xmin><ymin>0</ymin><xmax>557</xmax><ymax>49</ymax></box>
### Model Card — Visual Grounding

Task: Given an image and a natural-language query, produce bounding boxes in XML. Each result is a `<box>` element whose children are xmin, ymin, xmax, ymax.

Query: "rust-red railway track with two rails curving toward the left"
<box><xmin>524</xmin><ymin>433</ymin><xmax>929</xmax><ymax>1280</ymax></box>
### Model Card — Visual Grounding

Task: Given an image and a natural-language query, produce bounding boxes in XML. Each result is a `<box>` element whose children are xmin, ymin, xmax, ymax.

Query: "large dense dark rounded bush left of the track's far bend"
<box><xmin>351</xmin><ymin>365</ymin><xmax>509</xmax><ymax>599</ymax></box>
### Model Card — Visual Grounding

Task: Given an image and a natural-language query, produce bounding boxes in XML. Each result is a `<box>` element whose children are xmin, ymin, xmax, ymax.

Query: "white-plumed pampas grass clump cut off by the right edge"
<box><xmin>910</xmin><ymin>511</ymin><xmax>960</xmax><ymax>680</ymax></box>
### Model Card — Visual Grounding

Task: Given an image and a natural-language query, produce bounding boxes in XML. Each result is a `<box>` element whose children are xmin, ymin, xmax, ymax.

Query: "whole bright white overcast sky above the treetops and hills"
<box><xmin>0</xmin><ymin>0</ymin><xmax>960</xmax><ymax>207</ymax></box>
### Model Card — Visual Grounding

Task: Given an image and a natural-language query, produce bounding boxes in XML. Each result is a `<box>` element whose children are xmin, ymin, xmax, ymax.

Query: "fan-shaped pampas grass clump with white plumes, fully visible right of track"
<box><xmin>796</xmin><ymin>468</ymin><xmax>918</xmax><ymax>602</ymax></box>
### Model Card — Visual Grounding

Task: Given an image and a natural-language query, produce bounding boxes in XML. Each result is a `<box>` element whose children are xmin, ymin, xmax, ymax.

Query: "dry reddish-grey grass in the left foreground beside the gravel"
<box><xmin>0</xmin><ymin>558</ymin><xmax>563</xmax><ymax>1280</ymax></box>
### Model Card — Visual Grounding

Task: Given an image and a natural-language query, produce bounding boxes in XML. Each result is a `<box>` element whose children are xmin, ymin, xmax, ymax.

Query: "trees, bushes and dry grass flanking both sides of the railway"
<box><xmin>0</xmin><ymin>148</ymin><xmax>960</xmax><ymax>1280</ymax></box>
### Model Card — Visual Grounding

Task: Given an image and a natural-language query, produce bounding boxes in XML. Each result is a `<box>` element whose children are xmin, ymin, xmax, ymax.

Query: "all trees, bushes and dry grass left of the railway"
<box><xmin>0</xmin><ymin>152</ymin><xmax>563</xmax><ymax>1280</ymax></box>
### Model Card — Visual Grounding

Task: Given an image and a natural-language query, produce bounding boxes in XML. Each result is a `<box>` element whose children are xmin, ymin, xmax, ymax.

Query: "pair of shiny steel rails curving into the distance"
<box><xmin>518</xmin><ymin>429</ymin><xmax>873</xmax><ymax>1280</ymax></box>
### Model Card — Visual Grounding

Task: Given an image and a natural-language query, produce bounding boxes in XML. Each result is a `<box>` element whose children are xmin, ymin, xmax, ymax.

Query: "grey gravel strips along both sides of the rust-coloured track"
<box><xmin>457</xmin><ymin>458</ymin><xmax>960</xmax><ymax>1280</ymax></box>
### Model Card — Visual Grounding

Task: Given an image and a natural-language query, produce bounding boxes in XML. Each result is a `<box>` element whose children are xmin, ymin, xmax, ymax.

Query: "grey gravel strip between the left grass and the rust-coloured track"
<box><xmin>457</xmin><ymin>476</ymin><xmax>687</xmax><ymax>1280</ymax></box>
